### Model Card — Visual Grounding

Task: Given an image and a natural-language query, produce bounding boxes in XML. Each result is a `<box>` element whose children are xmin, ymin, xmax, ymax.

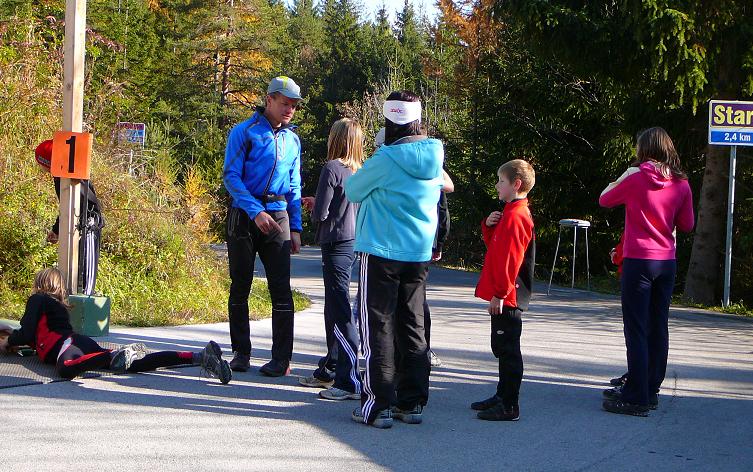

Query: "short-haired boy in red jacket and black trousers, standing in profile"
<box><xmin>471</xmin><ymin>159</ymin><xmax>536</xmax><ymax>421</ymax></box>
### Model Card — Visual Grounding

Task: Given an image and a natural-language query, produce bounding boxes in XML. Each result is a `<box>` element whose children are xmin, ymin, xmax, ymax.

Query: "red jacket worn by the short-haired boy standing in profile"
<box><xmin>476</xmin><ymin>198</ymin><xmax>536</xmax><ymax>310</ymax></box>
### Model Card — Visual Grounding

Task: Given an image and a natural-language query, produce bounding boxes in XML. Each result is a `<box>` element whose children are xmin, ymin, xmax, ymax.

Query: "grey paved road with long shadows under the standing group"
<box><xmin>0</xmin><ymin>248</ymin><xmax>753</xmax><ymax>472</ymax></box>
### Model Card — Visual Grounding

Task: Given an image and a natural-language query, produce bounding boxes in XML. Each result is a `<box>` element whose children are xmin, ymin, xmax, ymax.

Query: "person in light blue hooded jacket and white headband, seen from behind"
<box><xmin>345</xmin><ymin>91</ymin><xmax>444</xmax><ymax>428</ymax></box>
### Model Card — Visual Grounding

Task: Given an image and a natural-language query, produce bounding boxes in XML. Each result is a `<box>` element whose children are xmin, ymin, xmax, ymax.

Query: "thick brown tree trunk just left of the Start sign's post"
<box><xmin>683</xmin><ymin>146</ymin><xmax>729</xmax><ymax>305</ymax></box>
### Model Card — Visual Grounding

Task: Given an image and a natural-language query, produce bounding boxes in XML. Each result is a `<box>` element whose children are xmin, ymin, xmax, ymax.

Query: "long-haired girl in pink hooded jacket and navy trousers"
<box><xmin>599</xmin><ymin>128</ymin><xmax>694</xmax><ymax>416</ymax></box>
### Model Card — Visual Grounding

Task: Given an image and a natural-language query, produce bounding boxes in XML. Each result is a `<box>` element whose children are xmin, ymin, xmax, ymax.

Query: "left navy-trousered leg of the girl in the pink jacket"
<box><xmin>622</xmin><ymin>259</ymin><xmax>653</xmax><ymax>405</ymax></box>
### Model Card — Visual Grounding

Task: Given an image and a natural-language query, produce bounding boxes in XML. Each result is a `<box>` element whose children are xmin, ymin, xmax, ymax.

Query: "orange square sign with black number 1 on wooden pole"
<box><xmin>50</xmin><ymin>131</ymin><xmax>92</xmax><ymax>180</ymax></box>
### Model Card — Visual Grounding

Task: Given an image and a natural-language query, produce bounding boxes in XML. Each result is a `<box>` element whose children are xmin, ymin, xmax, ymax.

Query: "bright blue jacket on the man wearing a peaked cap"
<box><xmin>223</xmin><ymin>107</ymin><xmax>301</xmax><ymax>233</ymax></box>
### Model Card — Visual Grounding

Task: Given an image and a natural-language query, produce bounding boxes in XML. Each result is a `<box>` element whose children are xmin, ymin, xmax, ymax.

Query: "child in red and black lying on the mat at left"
<box><xmin>0</xmin><ymin>268</ymin><xmax>231</xmax><ymax>384</ymax></box>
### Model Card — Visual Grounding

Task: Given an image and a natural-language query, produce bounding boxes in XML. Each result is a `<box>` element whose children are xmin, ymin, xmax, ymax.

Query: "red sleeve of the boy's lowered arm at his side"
<box><xmin>491</xmin><ymin>211</ymin><xmax>533</xmax><ymax>300</ymax></box>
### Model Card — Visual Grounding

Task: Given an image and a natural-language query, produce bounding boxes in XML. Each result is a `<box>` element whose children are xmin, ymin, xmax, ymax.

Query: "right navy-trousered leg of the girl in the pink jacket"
<box><xmin>648</xmin><ymin>260</ymin><xmax>677</xmax><ymax>394</ymax></box>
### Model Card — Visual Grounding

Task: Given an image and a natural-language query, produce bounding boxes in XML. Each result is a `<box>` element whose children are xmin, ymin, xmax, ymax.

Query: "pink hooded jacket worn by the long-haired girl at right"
<box><xmin>599</xmin><ymin>162</ymin><xmax>695</xmax><ymax>260</ymax></box>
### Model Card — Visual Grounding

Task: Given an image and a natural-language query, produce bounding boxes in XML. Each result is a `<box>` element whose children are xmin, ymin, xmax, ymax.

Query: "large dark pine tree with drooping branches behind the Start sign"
<box><xmin>496</xmin><ymin>0</ymin><xmax>753</xmax><ymax>304</ymax></box>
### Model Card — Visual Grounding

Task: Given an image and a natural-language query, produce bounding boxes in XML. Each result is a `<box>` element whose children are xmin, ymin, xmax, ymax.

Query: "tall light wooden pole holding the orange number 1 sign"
<box><xmin>58</xmin><ymin>0</ymin><xmax>86</xmax><ymax>294</ymax></box>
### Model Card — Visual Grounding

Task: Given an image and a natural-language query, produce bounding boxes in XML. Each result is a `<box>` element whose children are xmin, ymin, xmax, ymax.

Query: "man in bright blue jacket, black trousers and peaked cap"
<box><xmin>223</xmin><ymin>76</ymin><xmax>301</xmax><ymax>377</ymax></box>
